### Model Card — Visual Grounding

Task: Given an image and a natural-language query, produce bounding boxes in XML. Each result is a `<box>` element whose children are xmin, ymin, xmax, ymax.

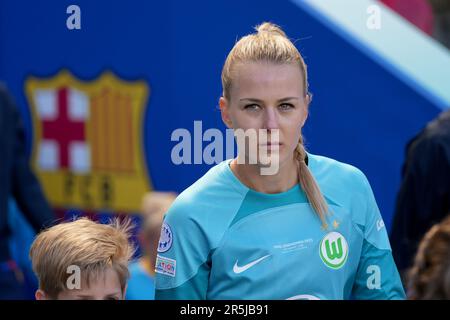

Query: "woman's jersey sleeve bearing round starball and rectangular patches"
<box><xmin>155</xmin><ymin>206</ymin><xmax>211</xmax><ymax>300</ymax></box>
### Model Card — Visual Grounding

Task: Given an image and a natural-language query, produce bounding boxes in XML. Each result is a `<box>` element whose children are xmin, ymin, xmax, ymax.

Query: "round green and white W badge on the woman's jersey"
<box><xmin>319</xmin><ymin>232</ymin><xmax>348</xmax><ymax>269</ymax></box>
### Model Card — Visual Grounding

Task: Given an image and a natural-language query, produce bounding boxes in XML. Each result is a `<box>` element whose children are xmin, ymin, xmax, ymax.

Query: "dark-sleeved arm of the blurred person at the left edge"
<box><xmin>5</xmin><ymin>90</ymin><xmax>55</xmax><ymax>232</ymax></box>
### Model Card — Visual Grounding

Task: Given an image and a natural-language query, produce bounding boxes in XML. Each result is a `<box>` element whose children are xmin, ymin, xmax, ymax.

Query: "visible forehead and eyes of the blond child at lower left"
<box><xmin>36</xmin><ymin>268</ymin><xmax>126</xmax><ymax>300</ymax></box>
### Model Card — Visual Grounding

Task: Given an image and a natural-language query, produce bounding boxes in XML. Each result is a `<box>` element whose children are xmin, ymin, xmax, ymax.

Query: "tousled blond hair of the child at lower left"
<box><xmin>30</xmin><ymin>218</ymin><xmax>134</xmax><ymax>299</ymax></box>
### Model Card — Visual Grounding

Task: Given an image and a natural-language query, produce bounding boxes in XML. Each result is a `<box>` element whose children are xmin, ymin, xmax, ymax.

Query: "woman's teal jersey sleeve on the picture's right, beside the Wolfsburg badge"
<box><xmin>352</xmin><ymin>177</ymin><xmax>405</xmax><ymax>300</ymax></box>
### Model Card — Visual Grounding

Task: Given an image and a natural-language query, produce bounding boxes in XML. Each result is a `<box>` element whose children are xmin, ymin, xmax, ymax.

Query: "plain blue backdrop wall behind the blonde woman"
<box><xmin>0</xmin><ymin>0</ymin><xmax>441</xmax><ymax>229</ymax></box>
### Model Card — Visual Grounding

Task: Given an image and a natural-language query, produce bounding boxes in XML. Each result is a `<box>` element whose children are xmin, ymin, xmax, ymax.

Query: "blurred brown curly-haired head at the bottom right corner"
<box><xmin>407</xmin><ymin>215</ymin><xmax>450</xmax><ymax>300</ymax></box>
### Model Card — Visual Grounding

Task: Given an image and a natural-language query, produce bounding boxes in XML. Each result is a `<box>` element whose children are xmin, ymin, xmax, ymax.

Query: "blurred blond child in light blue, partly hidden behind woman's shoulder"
<box><xmin>126</xmin><ymin>192</ymin><xmax>176</xmax><ymax>300</ymax></box>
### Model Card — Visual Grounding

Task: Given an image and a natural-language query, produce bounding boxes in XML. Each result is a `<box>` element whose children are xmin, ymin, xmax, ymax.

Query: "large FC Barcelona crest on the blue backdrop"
<box><xmin>25</xmin><ymin>71</ymin><xmax>151</xmax><ymax>212</ymax></box>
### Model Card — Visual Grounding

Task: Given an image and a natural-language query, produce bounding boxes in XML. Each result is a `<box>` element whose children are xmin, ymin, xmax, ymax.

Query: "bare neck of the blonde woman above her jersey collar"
<box><xmin>230</xmin><ymin>159</ymin><xmax>298</xmax><ymax>193</ymax></box>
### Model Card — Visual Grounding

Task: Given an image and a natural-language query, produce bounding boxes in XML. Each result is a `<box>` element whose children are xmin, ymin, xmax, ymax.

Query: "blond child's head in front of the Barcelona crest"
<box><xmin>30</xmin><ymin>218</ymin><xmax>134</xmax><ymax>300</ymax></box>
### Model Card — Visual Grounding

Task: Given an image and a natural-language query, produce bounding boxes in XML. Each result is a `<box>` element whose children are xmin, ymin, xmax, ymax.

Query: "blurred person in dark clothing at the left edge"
<box><xmin>0</xmin><ymin>83</ymin><xmax>55</xmax><ymax>299</ymax></box>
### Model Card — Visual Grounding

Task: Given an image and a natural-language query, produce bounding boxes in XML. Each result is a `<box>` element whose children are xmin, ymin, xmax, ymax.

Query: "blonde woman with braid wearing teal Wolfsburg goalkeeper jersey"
<box><xmin>156</xmin><ymin>23</ymin><xmax>405</xmax><ymax>299</ymax></box>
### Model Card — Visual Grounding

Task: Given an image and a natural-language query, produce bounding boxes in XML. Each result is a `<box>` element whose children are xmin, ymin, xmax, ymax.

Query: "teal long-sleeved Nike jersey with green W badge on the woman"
<box><xmin>155</xmin><ymin>154</ymin><xmax>405</xmax><ymax>299</ymax></box>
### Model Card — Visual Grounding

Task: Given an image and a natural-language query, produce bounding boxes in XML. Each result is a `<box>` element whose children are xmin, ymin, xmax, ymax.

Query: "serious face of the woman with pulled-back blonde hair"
<box><xmin>220</xmin><ymin>62</ymin><xmax>309</xmax><ymax>166</ymax></box>
